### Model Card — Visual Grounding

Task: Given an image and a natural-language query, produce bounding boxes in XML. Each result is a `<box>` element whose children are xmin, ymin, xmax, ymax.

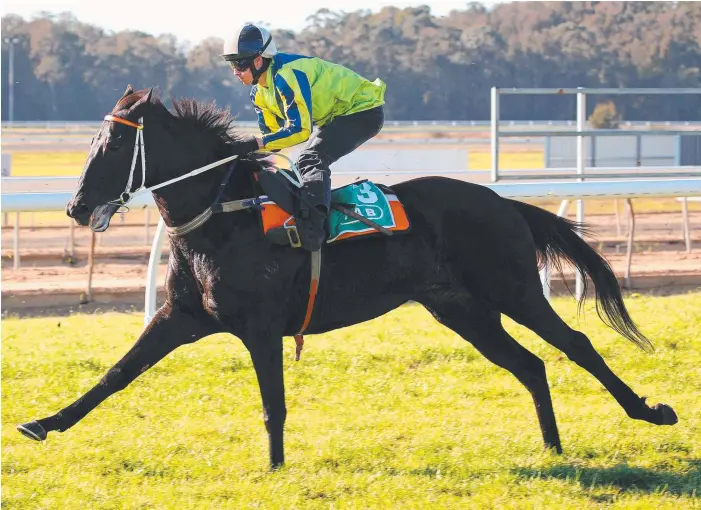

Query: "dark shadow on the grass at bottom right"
<box><xmin>514</xmin><ymin>459</ymin><xmax>701</xmax><ymax>496</ymax></box>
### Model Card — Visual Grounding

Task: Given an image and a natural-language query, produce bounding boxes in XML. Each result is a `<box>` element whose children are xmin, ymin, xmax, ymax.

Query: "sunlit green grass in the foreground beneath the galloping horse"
<box><xmin>2</xmin><ymin>293</ymin><xmax>701</xmax><ymax>510</ymax></box>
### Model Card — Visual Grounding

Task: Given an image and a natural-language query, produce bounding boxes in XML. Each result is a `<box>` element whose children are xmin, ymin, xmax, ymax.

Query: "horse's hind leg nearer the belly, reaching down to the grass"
<box><xmin>421</xmin><ymin>294</ymin><xmax>562</xmax><ymax>453</ymax></box>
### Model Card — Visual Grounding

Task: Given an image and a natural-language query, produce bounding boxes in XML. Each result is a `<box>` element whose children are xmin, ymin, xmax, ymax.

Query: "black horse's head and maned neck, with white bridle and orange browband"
<box><xmin>66</xmin><ymin>86</ymin><xmax>262</xmax><ymax>232</ymax></box>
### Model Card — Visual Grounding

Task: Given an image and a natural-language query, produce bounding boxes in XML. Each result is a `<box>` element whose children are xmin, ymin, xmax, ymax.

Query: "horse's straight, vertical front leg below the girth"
<box><xmin>245</xmin><ymin>335</ymin><xmax>287</xmax><ymax>469</ymax></box>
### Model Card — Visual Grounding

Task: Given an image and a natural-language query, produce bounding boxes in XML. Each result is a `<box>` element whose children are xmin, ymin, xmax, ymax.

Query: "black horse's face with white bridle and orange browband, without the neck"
<box><xmin>66</xmin><ymin>85</ymin><xmax>157</xmax><ymax>232</ymax></box>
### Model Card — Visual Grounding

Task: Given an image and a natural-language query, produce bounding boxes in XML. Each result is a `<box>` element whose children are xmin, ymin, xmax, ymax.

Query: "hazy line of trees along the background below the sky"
<box><xmin>1</xmin><ymin>2</ymin><xmax>701</xmax><ymax>121</ymax></box>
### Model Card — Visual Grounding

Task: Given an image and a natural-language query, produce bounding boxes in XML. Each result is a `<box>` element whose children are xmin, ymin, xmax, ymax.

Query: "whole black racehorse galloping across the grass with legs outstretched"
<box><xmin>18</xmin><ymin>87</ymin><xmax>677</xmax><ymax>467</ymax></box>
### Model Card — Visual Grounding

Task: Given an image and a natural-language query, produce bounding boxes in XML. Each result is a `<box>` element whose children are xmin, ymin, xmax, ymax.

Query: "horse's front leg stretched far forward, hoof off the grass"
<box><xmin>17</xmin><ymin>305</ymin><xmax>218</xmax><ymax>441</ymax></box>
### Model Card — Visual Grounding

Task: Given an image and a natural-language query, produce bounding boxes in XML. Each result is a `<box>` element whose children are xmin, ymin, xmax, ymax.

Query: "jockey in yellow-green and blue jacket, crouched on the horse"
<box><xmin>222</xmin><ymin>24</ymin><xmax>386</xmax><ymax>251</ymax></box>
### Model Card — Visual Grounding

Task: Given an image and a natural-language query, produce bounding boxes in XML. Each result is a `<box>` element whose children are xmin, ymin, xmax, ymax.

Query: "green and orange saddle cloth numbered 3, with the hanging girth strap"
<box><xmin>255</xmin><ymin>168</ymin><xmax>411</xmax><ymax>360</ymax></box>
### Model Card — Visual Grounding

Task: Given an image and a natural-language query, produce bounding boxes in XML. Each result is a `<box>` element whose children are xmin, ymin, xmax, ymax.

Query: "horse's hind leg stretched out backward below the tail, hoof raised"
<box><xmin>504</xmin><ymin>286</ymin><xmax>677</xmax><ymax>425</ymax></box>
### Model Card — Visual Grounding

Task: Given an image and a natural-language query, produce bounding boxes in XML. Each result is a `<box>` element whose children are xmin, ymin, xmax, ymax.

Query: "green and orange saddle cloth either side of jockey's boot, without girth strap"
<box><xmin>254</xmin><ymin>163</ymin><xmax>411</xmax><ymax>249</ymax></box>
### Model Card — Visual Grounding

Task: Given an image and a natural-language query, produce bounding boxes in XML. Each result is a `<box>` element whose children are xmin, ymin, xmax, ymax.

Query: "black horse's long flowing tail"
<box><xmin>510</xmin><ymin>200</ymin><xmax>653</xmax><ymax>351</ymax></box>
